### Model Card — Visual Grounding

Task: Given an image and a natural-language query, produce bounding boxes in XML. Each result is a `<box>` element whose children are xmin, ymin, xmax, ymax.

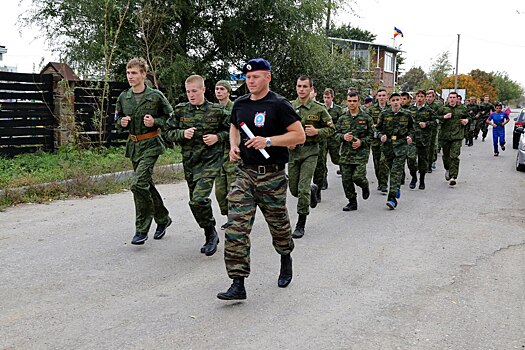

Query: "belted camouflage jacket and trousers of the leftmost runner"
<box><xmin>116</xmin><ymin>87</ymin><xmax>173</xmax><ymax>233</ymax></box>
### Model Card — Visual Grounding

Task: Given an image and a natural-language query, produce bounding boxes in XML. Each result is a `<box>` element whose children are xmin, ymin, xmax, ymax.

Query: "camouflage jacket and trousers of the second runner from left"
<box><xmin>167</xmin><ymin>101</ymin><xmax>230</xmax><ymax>228</ymax></box>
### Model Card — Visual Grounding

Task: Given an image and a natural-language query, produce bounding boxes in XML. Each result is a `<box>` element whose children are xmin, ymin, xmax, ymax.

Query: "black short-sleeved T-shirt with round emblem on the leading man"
<box><xmin>231</xmin><ymin>91</ymin><xmax>301</xmax><ymax>165</ymax></box>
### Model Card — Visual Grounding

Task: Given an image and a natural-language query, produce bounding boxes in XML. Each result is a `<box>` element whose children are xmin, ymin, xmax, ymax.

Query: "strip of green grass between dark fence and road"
<box><xmin>0</xmin><ymin>147</ymin><xmax>183</xmax><ymax>210</ymax></box>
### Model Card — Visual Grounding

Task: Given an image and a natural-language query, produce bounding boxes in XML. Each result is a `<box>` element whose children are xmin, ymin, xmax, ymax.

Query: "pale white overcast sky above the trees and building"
<box><xmin>0</xmin><ymin>0</ymin><xmax>525</xmax><ymax>87</ymax></box>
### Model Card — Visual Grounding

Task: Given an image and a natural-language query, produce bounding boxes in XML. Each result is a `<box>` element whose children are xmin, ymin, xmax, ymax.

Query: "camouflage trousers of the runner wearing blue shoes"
<box><xmin>381</xmin><ymin>140</ymin><xmax>408</xmax><ymax>199</ymax></box>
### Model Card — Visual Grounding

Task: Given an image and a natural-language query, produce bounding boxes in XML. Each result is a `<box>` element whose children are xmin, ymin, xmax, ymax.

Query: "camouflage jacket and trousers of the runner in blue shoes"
<box><xmin>376</xmin><ymin>108</ymin><xmax>414</xmax><ymax>201</ymax></box>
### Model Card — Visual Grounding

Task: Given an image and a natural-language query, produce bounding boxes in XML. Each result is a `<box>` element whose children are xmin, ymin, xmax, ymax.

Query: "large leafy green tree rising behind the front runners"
<box><xmin>23</xmin><ymin>0</ymin><xmax>362</xmax><ymax>101</ymax></box>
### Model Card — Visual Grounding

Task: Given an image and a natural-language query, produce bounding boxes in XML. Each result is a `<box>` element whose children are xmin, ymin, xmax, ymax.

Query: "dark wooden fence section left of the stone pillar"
<box><xmin>0</xmin><ymin>72</ymin><xmax>56</xmax><ymax>155</ymax></box>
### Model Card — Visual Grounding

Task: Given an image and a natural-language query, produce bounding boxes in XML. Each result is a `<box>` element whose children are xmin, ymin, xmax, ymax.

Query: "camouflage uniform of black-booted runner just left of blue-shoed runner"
<box><xmin>335</xmin><ymin>110</ymin><xmax>374</xmax><ymax>202</ymax></box>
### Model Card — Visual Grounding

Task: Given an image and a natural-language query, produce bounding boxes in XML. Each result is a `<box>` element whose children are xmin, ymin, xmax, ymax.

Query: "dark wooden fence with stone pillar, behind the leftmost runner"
<box><xmin>0</xmin><ymin>72</ymin><xmax>129</xmax><ymax>156</ymax></box>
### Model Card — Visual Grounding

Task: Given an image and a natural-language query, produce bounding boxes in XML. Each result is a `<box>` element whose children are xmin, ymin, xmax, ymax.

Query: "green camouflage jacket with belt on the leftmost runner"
<box><xmin>115</xmin><ymin>86</ymin><xmax>173</xmax><ymax>162</ymax></box>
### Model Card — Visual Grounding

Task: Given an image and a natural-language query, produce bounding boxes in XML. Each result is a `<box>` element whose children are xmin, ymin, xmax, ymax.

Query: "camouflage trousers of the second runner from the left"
<box><xmin>184</xmin><ymin>165</ymin><xmax>217</xmax><ymax>228</ymax></box>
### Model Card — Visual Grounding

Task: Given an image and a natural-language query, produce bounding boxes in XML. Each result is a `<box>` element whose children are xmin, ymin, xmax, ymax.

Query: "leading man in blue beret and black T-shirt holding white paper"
<box><xmin>217</xmin><ymin>58</ymin><xmax>306</xmax><ymax>300</ymax></box>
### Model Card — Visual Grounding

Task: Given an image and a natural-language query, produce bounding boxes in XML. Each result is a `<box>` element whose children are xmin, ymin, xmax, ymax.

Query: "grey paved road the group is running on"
<box><xmin>0</xmin><ymin>118</ymin><xmax>525</xmax><ymax>350</ymax></box>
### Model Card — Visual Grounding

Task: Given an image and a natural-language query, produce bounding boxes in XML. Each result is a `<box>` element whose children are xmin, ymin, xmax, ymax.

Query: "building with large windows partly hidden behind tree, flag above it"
<box><xmin>328</xmin><ymin>37</ymin><xmax>403</xmax><ymax>93</ymax></box>
